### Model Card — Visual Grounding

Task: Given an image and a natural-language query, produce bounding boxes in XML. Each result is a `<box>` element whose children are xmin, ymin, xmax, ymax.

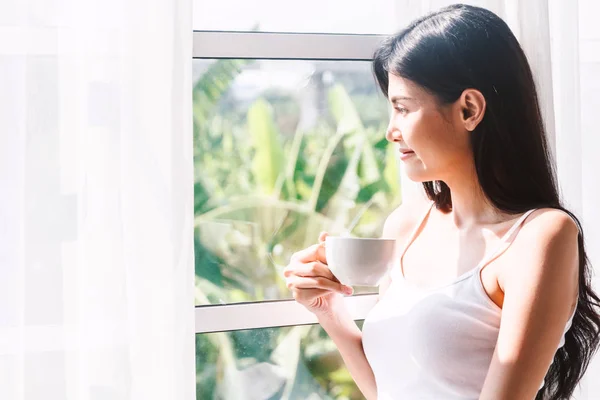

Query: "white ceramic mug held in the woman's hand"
<box><xmin>325</xmin><ymin>236</ymin><xmax>396</xmax><ymax>286</ymax></box>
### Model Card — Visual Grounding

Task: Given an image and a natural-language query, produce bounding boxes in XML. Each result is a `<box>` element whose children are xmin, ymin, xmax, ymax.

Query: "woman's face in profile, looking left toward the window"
<box><xmin>386</xmin><ymin>74</ymin><xmax>473</xmax><ymax>182</ymax></box>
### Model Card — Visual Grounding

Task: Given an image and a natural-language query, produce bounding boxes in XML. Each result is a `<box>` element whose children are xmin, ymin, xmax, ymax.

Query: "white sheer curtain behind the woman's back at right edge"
<box><xmin>550</xmin><ymin>0</ymin><xmax>600</xmax><ymax>400</ymax></box>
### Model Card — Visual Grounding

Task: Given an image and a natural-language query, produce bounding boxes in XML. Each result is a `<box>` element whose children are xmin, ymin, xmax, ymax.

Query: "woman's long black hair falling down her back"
<box><xmin>373</xmin><ymin>4</ymin><xmax>600</xmax><ymax>400</ymax></box>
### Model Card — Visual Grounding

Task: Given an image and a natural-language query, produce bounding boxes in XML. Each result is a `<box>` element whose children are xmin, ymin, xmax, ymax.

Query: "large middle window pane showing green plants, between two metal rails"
<box><xmin>194</xmin><ymin>60</ymin><xmax>400</xmax><ymax>305</ymax></box>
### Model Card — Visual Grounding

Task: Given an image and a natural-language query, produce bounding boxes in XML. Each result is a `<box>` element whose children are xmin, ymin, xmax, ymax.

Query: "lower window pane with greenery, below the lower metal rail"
<box><xmin>196</xmin><ymin>322</ymin><xmax>364</xmax><ymax>400</ymax></box>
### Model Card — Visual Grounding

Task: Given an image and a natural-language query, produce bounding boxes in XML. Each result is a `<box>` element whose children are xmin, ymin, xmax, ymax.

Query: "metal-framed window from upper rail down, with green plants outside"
<box><xmin>193</xmin><ymin>32</ymin><xmax>400</xmax><ymax>399</ymax></box>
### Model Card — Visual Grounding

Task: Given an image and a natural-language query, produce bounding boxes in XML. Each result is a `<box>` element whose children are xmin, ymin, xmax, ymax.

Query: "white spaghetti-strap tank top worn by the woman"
<box><xmin>363</xmin><ymin>205</ymin><xmax>573</xmax><ymax>400</ymax></box>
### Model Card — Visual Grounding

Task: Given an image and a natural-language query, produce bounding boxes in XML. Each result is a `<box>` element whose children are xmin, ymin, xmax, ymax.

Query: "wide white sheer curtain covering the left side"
<box><xmin>0</xmin><ymin>0</ymin><xmax>195</xmax><ymax>400</ymax></box>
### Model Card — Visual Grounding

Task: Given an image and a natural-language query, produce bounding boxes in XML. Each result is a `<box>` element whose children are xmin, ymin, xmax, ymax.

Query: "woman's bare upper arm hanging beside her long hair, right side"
<box><xmin>480</xmin><ymin>209</ymin><xmax>579</xmax><ymax>400</ymax></box>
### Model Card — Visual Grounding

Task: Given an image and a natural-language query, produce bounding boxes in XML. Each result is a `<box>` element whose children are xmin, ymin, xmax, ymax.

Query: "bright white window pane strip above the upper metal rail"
<box><xmin>193</xmin><ymin>0</ymin><xmax>420</xmax><ymax>34</ymax></box>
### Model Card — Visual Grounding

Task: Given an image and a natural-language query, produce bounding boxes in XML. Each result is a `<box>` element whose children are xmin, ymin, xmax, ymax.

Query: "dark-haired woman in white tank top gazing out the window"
<box><xmin>284</xmin><ymin>5</ymin><xmax>600</xmax><ymax>400</ymax></box>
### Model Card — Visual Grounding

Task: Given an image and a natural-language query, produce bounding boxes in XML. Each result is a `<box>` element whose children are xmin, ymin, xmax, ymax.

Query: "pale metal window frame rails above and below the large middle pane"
<box><xmin>192</xmin><ymin>31</ymin><xmax>385</xmax><ymax>334</ymax></box>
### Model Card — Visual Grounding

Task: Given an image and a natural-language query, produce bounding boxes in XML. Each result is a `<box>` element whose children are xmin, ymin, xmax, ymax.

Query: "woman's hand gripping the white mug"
<box><xmin>283</xmin><ymin>232</ymin><xmax>353</xmax><ymax>315</ymax></box>
